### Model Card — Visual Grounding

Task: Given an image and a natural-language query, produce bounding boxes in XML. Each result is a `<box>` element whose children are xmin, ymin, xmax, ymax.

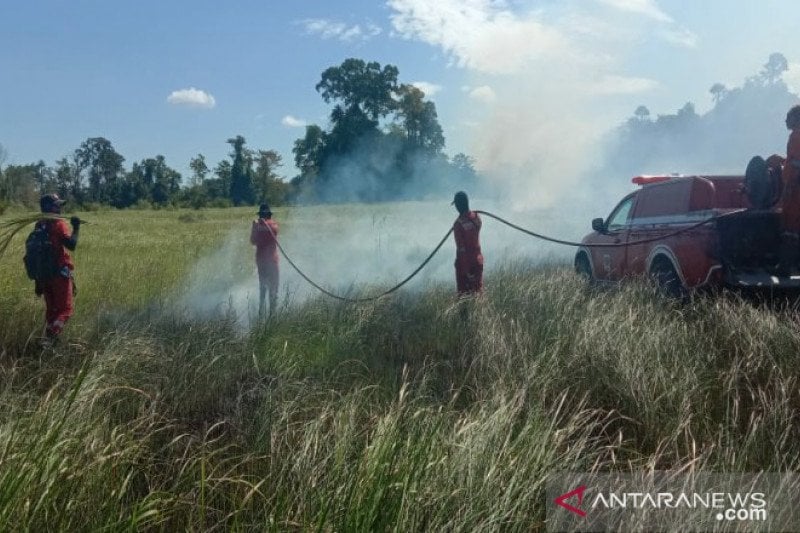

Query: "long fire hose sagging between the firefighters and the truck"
<box><xmin>267</xmin><ymin>209</ymin><xmax>746</xmax><ymax>303</ymax></box>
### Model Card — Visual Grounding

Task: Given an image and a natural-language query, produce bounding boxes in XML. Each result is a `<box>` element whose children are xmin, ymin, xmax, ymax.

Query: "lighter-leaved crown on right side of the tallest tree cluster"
<box><xmin>397</xmin><ymin>85</ymin><xmax>444</xmax><ymax>154</ymax></box>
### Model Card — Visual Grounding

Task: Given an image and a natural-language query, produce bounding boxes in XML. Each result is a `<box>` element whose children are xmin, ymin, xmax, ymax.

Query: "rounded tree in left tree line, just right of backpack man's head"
<box><xmin>75</xmin><ymin>137</ymin><xmax>125</xmax><ymax>202</ymax></box>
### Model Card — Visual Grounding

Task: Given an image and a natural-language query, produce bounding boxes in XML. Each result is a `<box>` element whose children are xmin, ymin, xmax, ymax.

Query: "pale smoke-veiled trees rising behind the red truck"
<box><xmin>601</xmin><ymin>52</ymin><xmax>800</xmax><ymax>178</ymax></box>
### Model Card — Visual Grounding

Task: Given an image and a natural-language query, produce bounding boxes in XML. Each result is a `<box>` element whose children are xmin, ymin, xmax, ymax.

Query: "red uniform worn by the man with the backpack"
<box><xmin>37</xmin><ymin>219</ymin><xmax>74</xmax><ymax>336</ymax></box>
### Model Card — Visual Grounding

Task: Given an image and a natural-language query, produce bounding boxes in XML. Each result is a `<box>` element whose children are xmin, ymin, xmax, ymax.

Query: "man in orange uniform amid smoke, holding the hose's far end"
<box><xmin>250</xmin><ymin>204</ymin><xmax>278</xmax><ymax>318</ymax></box>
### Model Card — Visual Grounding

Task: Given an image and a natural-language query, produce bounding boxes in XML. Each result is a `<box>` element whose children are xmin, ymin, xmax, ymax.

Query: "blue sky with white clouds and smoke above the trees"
<box><xmin>0</xmin><ymin>0</ymin><xmax>800</xmax><ymax>187</ymax></box>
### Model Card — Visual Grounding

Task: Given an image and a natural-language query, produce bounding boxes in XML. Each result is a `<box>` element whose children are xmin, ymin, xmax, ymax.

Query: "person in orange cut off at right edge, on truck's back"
<box><xmin>779</xmin><ymin>105</ymin><xmax>800</xmax><ymax>274</ymax></box>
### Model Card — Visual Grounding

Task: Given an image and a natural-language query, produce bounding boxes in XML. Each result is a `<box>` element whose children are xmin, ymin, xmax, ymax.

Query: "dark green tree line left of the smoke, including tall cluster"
<box><xmin>0</xmin><ymin>58</ymin><xmax>478</xmax><ymax>208</ymax></box>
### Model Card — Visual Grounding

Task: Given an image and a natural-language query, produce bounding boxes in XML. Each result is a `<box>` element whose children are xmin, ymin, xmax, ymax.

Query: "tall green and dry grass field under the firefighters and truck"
<box><xmin>0</xmin><ymin>206</ymin><xmax>800</xmax><ymax>531</ymax></box>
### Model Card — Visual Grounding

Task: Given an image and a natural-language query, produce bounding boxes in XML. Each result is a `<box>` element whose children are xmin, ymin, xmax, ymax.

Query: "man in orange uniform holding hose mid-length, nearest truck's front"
<box><xmin>451</xmin><ymin>191</ymin><xmax>483</xmax><ymax>295</ymax></box>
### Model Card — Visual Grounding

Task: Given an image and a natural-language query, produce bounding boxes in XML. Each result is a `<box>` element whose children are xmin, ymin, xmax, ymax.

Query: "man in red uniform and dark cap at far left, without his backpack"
<box><xmin>35</xmin><ymin>194</ymin><xmax>81</xmax><ymax>346</ymax></box>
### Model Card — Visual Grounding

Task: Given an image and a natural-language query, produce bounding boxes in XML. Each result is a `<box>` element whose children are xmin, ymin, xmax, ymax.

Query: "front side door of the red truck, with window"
<box><xmin>591</xmin><ymin>193</ymin><xmax>636</xmax><ymax>281</ymax></box>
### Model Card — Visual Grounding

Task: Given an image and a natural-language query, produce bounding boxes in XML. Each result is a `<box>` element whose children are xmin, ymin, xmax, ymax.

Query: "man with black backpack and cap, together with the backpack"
<box><xmin>25</xmin><ymin>194</ymin><xmax>81</xmax><ymax>344</ymax></box>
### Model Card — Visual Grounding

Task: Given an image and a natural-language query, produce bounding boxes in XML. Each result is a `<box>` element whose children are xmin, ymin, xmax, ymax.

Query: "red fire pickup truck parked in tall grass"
<box><xmin>575</xmin><ymin>175</ymin><xmax>788</xmax><ymax>296</ymax></box>
